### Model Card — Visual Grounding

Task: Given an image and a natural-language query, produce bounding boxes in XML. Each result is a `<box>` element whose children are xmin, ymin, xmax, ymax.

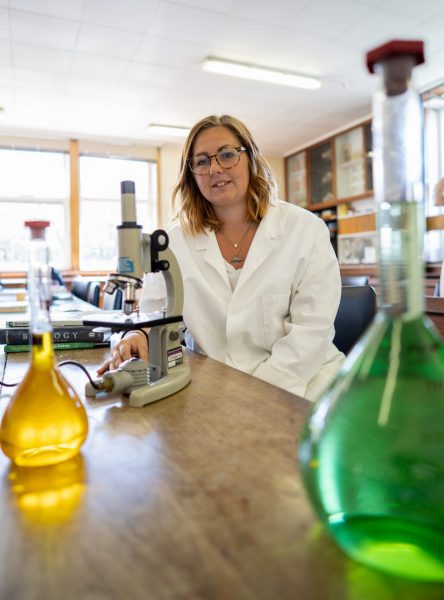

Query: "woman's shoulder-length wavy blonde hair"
<box><xmin>172</xmin><ymin>115</ymin><xmax>277</xmax><ymax>235</ymax></box>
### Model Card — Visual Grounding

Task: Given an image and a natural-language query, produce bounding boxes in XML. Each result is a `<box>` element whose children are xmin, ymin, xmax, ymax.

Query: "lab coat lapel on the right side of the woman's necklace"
<box><xmin>235</xmin><ymin>202</ymin><xmax>282</xmax><ymax>291</ymax></box>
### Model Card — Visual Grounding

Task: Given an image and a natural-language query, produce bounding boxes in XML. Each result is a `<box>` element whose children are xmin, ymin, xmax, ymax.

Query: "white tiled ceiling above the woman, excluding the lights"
<box><xmin>0</xmin><ymin>0</ymin><xmax>444</xmax><ymax>156</ymax></box>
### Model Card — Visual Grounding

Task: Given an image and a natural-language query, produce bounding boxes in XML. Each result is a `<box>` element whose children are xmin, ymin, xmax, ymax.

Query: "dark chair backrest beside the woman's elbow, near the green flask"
<box><xmin>333</xmin><ymin>285</ymin><xmax>377</xmax><ymax>354</ymax></box>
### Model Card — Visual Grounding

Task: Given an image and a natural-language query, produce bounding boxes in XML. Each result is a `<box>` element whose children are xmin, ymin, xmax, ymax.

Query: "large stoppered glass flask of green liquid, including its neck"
<box><xmin>299</xmin><ymin>41</ymin><xmax>444</xmax><ymax>581</ymax></box>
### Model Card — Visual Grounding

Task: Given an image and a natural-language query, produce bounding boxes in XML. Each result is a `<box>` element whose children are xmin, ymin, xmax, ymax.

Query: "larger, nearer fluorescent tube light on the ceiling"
<box><xmin>202</xmin><ymin>56</ymin><xmax>321</xmax><ymax>90</ymax></box>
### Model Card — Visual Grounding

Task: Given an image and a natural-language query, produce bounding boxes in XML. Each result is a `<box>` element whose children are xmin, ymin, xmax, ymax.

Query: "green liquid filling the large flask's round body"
<box><xmin>299</xmin><ymin>314</ymin><xmax>444</xmax><ymax>581</ymax></box>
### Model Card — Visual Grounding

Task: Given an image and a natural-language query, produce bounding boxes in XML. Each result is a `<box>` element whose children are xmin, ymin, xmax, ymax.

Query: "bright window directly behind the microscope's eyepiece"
<box><xmin>80</xmin><ymin>156</ymin><xmax>157</xmax><ymax>271</ymax></box>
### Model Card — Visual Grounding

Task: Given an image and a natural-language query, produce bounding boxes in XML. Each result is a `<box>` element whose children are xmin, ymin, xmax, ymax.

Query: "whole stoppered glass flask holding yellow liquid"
<box><xmin>0</xmin><ymin>221</ymin><xmax>88</xmax><ymax>467</ymax></box>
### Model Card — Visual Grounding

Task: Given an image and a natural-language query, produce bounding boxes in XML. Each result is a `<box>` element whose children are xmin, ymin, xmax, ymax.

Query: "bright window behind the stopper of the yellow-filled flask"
<box><xmin>0</xmin><ymin>148</ymin><xmax>70</xmax><ymax>271</ymax></box>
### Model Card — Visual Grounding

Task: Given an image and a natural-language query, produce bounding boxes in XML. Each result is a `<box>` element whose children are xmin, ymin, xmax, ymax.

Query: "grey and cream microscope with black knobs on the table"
<box><xmin>83</xmin><ymin>181</ymin><xmax>191</xmax><ymax>407</ymax></box>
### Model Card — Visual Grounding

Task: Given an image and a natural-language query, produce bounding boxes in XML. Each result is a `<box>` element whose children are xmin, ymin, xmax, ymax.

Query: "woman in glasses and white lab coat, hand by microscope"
<box><xmin>99</xmin><ymin>115</ymin><xmax>343</xmax><ymax>398</ymax></box>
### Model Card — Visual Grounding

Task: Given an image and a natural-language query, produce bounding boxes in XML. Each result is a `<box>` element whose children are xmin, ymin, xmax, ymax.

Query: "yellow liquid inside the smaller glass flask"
<box><xmin>0</xmin><ymin>332</ymin><xmax>88</xmax><ymax>467</ymax></box>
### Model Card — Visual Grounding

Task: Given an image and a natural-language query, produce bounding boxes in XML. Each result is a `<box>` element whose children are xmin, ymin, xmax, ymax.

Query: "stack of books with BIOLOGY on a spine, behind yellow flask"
<box><xmin>0</xmin><ymin>319</ymin><xmax>110</xmax><ymax>353</ymax></box>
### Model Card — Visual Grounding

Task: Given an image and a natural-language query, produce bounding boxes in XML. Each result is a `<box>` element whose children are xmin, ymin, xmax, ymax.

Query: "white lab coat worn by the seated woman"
<box><xmin>141</xmin><ymin>200</ymin><xmax>344</xmax><ymax>399</ymax></box>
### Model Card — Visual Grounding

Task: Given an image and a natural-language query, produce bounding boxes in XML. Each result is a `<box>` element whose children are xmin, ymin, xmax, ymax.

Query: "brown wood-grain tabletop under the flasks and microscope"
<box><xmin>0</xmin><ymin>350</ymin><xmax>444</xmax><ymax>600</ymax></box>
